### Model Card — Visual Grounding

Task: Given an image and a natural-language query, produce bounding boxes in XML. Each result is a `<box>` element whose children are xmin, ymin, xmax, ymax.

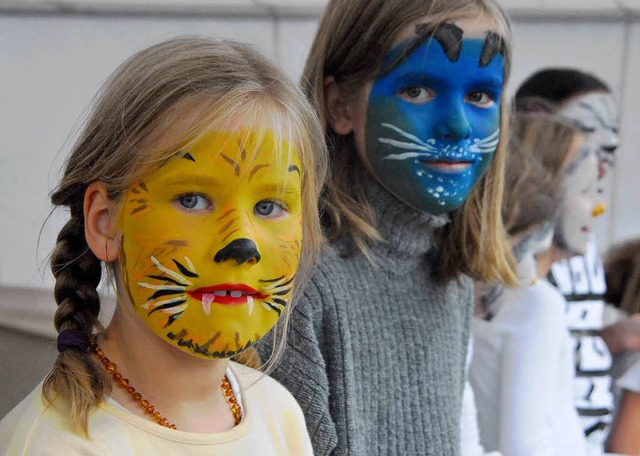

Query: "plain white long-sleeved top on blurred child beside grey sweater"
<box><xmin>469</xmin><ymin>280</ymin><xmax>586</xmax><ymax>456</ymax></box>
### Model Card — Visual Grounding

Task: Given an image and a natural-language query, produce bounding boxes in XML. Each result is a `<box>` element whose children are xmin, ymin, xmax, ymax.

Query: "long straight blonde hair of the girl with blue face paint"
<box><xmin>302</xmin><ymin>0</ymin><xmax>516</xmax><ymax>284</ymax></box>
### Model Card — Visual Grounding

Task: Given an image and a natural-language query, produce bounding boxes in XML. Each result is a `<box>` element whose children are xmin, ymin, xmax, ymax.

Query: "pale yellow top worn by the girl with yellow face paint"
<box><xmin>0</xmin><ymin>363</ymin><xmax>313</xmax><ymax>456</ymax></box>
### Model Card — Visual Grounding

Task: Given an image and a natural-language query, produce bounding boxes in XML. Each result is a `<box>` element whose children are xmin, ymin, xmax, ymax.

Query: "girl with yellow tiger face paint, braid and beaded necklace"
<box><xmin>0</xmin><ymin>38</ymin><xmax>326</xmax><ymax>455</ymax></box>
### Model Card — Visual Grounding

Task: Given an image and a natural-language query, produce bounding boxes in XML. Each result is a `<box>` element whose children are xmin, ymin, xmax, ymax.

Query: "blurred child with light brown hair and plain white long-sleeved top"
<box><xmin>469</xmin><ymin>114</ymin><xmax>597</xmax><ymax>456</ymax></box>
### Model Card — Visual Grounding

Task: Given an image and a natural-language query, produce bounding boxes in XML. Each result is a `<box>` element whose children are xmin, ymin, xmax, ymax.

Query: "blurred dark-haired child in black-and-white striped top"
<box><xmin>515</xmin><ymin>68</ymin><xmax>618</xmax><ymax>448</ymax></box>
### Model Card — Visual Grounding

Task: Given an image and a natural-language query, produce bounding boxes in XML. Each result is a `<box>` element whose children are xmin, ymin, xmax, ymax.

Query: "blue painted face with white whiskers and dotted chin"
<box><xmin>365</xmin><ymin>29</ymin><xmax>504</xmax><ymax>214</ymax></box>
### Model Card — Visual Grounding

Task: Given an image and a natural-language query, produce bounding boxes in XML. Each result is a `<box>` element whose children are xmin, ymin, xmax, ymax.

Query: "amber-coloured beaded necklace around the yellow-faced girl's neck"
<box><xmin>90</xmin><ymin>341</ymin><xmax>242</xmax><ymax>429</ymax></box>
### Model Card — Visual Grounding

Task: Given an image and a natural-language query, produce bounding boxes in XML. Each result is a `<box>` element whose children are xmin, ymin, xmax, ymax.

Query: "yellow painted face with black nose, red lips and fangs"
<box><xmin>121</xmin><ymin>131</ymin><xmax>302</xmax><ymax>358</ymax></box>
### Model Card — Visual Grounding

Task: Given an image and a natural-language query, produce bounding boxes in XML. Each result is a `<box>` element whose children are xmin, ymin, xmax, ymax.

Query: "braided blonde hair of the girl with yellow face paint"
<box><xmin>43</xmin><ymin>37</ymin><xmax>327</xmax><ymax>433</ymax></box>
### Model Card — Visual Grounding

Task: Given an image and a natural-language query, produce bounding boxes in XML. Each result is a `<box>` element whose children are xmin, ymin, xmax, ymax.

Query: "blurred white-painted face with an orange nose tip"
<box><xmin>554</xmin><ymin>146</ymin><xmax>604</xmax><ymax>255</ymax></box>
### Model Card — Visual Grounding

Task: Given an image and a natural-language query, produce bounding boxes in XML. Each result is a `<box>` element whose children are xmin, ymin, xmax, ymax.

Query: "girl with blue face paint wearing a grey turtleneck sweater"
<box><xmin>259</xmin><ymin>0</ymin><xmax>515</xmax><ymax>456</ymax></box>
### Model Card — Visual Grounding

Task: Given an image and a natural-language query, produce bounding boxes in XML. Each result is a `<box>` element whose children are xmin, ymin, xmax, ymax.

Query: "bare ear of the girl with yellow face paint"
<box><xmin>84</xmin><ymin>182</ymin><xmax>120</xmax><ymax>262</ymax></box>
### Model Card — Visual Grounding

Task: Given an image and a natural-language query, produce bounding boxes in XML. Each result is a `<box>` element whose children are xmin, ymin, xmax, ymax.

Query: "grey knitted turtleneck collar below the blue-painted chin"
<box><xmin>360</xmin><ymin>179</ymin><xmax>450</xmax><ymax>261</ymax></box>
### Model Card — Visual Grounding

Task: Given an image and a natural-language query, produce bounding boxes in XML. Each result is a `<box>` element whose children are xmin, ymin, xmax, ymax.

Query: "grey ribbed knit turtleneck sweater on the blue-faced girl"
<box><xmin>262</xmin><ymin>180</ymin><xmax>472</xmax><ymax>456</ymax></box>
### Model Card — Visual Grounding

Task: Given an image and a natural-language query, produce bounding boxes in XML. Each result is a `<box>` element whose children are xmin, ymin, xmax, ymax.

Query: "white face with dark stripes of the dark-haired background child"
<box><xmin>560</xmin><ymin>92</ymin><xmax>618</xmax><ymax>178</ymax></box>
